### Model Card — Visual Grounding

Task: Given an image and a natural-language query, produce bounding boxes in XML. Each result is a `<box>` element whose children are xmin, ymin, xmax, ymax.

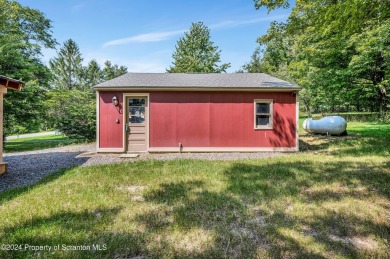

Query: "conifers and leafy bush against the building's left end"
<box><xmin>46</xmin><ymin>39</ymin><xmax>127</xmax><ymax>140</ymax></box>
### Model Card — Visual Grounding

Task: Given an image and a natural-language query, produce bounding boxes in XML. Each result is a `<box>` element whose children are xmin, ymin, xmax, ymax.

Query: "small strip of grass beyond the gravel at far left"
<box><xmin>4</xmin><ymin>135</ymin><xmax>81</xmax><ymax>153</ymax></box>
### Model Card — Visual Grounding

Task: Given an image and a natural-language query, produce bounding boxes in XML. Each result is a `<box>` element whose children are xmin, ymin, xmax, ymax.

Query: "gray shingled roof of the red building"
<box><xmin>95</xmin><ymin>73</ymin><xmax>300</xmax><ymax>90</ymax></box>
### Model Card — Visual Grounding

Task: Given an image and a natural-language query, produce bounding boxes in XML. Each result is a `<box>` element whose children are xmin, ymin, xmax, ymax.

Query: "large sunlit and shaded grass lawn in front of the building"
<box><xmin>0</xmin><ymin>123</ymin><xmax>390</xmax><ymax>258</ymax></box>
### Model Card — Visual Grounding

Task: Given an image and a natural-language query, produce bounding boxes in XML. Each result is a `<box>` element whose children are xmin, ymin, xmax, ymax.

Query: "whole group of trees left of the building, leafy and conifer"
<box><xmin>0</xmin><ymin>0</ymin><xmax>127</xmax><ymax>140</ymax></box>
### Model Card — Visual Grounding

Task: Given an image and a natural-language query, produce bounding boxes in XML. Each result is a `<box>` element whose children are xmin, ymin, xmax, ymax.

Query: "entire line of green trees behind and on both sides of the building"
<box><xmin>0</xmin><ymin>0</ymin><xmax>390</xmax><ymax>140</ymax></box>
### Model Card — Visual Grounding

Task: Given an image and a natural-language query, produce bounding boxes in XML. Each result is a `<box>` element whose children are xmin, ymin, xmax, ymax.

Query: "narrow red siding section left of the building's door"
<box><xmin>99</xmin><ymin>92</ymin><xmax>124</xmax><ymax>148</ymax></box>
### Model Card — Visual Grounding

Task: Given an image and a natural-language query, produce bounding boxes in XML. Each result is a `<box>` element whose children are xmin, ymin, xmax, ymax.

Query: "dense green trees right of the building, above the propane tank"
<box><xmin>242</xmin><ymin>0</ymin><xmax>390</xmax><ymax>115</ymax></box>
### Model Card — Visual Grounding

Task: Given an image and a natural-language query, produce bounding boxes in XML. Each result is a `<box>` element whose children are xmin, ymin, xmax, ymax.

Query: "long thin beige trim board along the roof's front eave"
<box><xmin>95</xmin><ymin>86</ymin><xmax>301</xmax><ymax>92</ymax></box>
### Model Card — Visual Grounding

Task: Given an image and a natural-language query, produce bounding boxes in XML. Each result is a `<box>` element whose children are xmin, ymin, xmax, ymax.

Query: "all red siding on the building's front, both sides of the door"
<box><xmin>99</xmin><ymin>92</ymin><xmax>296</xmax><ymax>148</ymax></box>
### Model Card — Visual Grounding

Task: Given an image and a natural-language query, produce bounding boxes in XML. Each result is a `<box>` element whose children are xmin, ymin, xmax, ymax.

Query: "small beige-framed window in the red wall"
<box><xmin>254</xmin><ymin>100</ymin><xmax>273</xmax><ymax>129</ymax></box>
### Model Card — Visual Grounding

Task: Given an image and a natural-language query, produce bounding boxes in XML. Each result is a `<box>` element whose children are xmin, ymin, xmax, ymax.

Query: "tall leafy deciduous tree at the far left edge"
<box><xmin>0</xmin><ymin>0</ymin><xmax>56</xmax><ymax>135</ymax></box>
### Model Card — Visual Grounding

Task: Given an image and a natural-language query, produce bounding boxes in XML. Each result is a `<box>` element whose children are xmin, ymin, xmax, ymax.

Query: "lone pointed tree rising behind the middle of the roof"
<box><xmin>167</xmin><ymin>22</ymin><xmax>230</xmax><ymax>73</ymax></box>
